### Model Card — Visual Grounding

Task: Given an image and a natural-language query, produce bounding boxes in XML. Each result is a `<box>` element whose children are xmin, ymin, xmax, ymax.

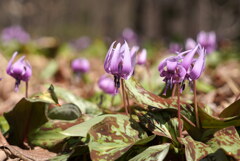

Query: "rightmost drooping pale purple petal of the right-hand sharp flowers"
<box><xmin>189</xmin><ymin>48</ymin><xmax>206</xmax><ymax>80</ymax></box>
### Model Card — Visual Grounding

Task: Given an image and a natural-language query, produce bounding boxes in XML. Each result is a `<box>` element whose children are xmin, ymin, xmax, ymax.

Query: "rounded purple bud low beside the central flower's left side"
<box><xmin>98</xmin><ymin>75</ymin><xmax>117</xmax><ymax>95</ymax></box>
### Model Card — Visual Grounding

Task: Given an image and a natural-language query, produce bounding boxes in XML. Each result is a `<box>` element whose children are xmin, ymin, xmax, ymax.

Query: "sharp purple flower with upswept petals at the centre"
<box><xmin>104</xmin><ymin>41</ymin><xmax>136</xmax><ymax>88</ymax></box>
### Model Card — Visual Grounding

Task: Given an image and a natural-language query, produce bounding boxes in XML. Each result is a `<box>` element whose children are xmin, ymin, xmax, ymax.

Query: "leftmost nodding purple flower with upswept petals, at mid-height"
<box><xmin>6</xmin><ymin>52</ymin><xmax>32</xmax><ymax>91</ymax></box>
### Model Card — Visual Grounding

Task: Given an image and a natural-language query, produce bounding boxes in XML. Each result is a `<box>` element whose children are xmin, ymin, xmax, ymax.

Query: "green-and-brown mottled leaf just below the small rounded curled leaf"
<box><xmin>29</xmin><ymin>118</ymin><xmax>84</xmax><ymax>149</ymax></box>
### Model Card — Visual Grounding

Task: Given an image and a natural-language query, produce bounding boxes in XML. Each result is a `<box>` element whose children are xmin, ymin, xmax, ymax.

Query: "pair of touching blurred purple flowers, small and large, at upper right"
<box><xmin>185</xmin><ymin>31</ymin><xmax>217</xmax><ymax>54</ymax></box>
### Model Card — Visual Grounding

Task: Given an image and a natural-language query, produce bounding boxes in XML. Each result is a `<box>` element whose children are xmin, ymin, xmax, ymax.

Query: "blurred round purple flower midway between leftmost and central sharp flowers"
<box><xmin>71</xmin><ymin>58</ymin><xmax>90</xmax><ymax>74</ymax></box>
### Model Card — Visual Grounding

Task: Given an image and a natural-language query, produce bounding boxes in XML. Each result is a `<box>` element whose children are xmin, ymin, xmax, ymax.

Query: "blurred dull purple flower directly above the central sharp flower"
<box><xmin>122</xmin><ymin>28</ymin><xmax>138</xmax><ymax>46</ymax></box>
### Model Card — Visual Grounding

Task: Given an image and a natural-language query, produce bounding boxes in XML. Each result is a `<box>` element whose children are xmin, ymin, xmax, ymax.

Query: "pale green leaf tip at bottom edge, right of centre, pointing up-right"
<box><xmin>130</xmin><ymin>143</ymin><xmax>170</xmax><ymax>161</ymax></box>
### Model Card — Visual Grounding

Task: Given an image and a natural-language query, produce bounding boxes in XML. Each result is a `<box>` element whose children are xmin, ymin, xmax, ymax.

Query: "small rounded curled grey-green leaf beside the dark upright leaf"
<box><xmin>48</xmin><ymin>103</ymin><xmax>81</xmax><ymax>120</ymax></box>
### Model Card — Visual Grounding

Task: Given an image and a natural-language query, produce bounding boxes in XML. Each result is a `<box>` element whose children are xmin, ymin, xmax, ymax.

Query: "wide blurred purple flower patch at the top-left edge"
<box><xmin>1</xmin><ymin>26</ymin><xmax>30</xmax><ymax>44</ymax></box>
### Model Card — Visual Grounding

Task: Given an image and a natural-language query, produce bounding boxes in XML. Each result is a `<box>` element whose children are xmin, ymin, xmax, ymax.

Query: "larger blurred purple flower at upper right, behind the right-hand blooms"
<box><xmin>197</xmin><ymin>31</ymin><xmax>217</xmax><ymax>54</ymax></box>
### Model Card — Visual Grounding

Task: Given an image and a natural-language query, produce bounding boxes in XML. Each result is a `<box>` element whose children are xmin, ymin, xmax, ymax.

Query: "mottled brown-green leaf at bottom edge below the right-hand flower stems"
<box><xmin>180</xmin><ymin>136</ymin><xmax>213</xmax><ymax>161</ymax></box>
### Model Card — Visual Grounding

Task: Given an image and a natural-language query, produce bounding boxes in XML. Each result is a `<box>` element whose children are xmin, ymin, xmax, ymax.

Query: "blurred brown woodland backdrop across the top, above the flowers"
<box><xmin>0</xmin><ymin>0</ymin><xmax>240</xmax><ymax>42</ymax></box>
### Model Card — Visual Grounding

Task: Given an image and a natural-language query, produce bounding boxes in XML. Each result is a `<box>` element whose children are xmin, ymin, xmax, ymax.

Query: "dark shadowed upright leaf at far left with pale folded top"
<box><xmin>4</xmin><ymin>86</ymin><xmax>55</xmax><ymax>145</ymax></box>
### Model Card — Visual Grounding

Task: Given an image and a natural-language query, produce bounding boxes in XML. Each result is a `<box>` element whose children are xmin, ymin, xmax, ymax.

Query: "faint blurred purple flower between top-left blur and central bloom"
<box><xmin>70</xmin><ymin>36</ymin><xmax>91</xmax><ymax>51</ymax></box>
